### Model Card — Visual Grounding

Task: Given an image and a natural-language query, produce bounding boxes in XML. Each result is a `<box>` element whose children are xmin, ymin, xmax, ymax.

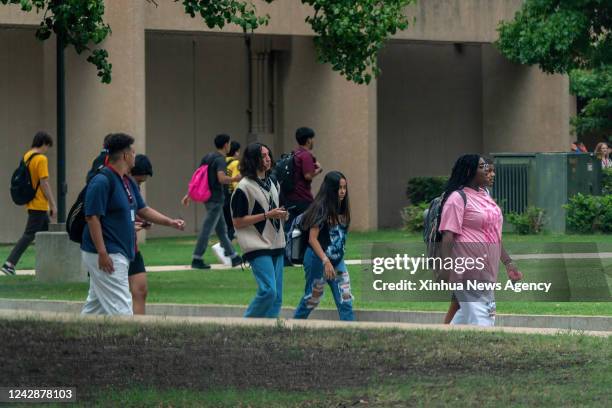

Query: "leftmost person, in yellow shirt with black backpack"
<box><xmin>1</xmin><ymin>132</ymin><xmax>57</xmax><ymax>275</ymax></box>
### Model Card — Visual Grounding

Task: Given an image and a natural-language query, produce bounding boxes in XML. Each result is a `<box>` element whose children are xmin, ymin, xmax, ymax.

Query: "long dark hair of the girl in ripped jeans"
<box><xmin>301</xmin><ymin>171</ymin><xmax>351</xmax><ymax>230</ymax></box>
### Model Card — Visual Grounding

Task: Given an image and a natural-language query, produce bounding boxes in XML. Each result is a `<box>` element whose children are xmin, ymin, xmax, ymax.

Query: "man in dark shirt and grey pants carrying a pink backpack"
<box><xmin>181</xmin><ymin>134</ymin><xmax>242</xmax><ymax>269</ymax></box>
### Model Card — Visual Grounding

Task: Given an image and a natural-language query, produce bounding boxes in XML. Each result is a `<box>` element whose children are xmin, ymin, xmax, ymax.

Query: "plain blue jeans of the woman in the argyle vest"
<box><xmin>244</xmin><ymin>255</ymin><xmax>284</xmax><ymax>318</ymax></box>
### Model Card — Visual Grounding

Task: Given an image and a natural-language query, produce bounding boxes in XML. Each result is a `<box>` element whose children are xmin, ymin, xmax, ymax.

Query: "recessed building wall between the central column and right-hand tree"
<box><xmin>378</xmin><ymin>42</ymin><xmax>575</xmax><ymax>227</ymax></box>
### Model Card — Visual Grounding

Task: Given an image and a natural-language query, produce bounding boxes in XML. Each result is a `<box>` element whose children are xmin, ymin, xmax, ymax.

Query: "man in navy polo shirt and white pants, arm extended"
<box><xmin>81</xmin><ymin>133</ymin><xmax>185</xmax><ymax>315</ymax></box>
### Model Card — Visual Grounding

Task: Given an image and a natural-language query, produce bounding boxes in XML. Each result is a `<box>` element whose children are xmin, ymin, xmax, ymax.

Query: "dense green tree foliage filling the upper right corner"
<box><xmin>497</xmin><ymin>0</ymin><xmax>612</xmax><ymax>134</ymax></box>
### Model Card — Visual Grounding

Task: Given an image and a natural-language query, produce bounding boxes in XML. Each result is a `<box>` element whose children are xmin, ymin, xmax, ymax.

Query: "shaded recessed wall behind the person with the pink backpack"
<box><xmin>146</xmin><ymin>32</ymin><xmax>248</xmax><ymax>236</ymax></box>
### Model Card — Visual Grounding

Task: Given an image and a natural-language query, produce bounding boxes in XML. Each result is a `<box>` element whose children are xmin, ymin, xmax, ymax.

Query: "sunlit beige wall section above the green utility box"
<box><xmin>482</xmin><ymin>44</ymin><xmax>575</xmax><ymax>153</ymax></box>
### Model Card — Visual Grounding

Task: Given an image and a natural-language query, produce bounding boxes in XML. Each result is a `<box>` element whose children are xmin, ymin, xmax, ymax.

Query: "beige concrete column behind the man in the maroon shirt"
<box><xmin>281</xmin><ymin>37</ymin><xmax>378</xmax><ymax>229</ymax></box>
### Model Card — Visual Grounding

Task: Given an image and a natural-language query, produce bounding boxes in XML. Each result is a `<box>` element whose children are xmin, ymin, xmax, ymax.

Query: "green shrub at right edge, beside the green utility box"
<box><xmin>563</xmin><ymin>194</ymin><xmax>612</xmax><ymax>233</ymax></box>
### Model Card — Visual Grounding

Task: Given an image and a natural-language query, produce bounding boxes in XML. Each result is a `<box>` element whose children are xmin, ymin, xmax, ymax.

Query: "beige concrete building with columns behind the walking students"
<box><xmin>0</xmin><ymin>0</ymin><xmax>575</xmax><ymax>242</ymax></box>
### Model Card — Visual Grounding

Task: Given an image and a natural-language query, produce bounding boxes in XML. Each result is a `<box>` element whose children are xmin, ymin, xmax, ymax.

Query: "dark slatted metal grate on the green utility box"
<box><xmin>493</xmin><ymin>163</ymin><xmax>529</xmax><ymax>214</ymax></box>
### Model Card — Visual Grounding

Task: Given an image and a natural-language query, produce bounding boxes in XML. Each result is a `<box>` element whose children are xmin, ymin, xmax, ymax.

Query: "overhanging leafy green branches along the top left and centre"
<box><xmin>0</xmin><ymin>0</ymin><xmax>415</xmax><ymax>84</ymax></box>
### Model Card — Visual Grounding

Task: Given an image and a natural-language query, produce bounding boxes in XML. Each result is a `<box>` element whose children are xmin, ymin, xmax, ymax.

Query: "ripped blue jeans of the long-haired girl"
<box><xmin>293</xmin><ymin>248</ymin><xmax>355</xmax><ymax>320</ymax></box>
